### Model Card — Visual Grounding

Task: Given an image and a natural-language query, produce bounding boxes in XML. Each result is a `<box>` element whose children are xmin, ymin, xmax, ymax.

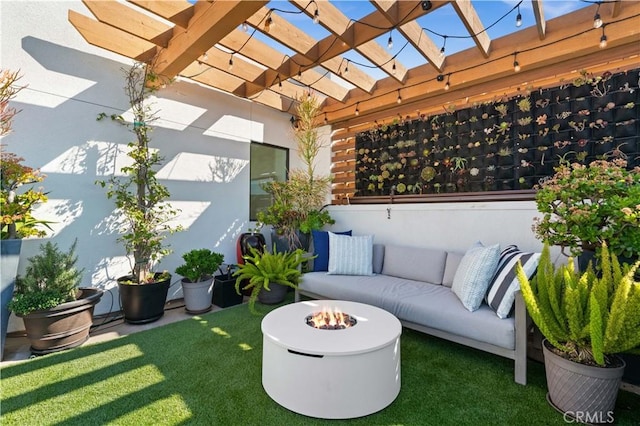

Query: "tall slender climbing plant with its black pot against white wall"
<box><xmin>97</xmin><ymin>63</ymin><xmax>181</xmax><ymax>324</ymax></box>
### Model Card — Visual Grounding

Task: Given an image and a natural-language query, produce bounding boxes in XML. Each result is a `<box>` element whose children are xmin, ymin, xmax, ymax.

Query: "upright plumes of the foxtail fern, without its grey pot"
<box><xmin>516</xmin><ymin>244</ymin><xmax>640</xmax><ymax>366</ymax></box>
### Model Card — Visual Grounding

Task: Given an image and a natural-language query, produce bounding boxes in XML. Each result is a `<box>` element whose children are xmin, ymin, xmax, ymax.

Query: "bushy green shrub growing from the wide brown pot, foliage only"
<box><xmin>9</xmin><ymin>241</ymin><xmax>84</xmax><ymax>315</ymax></box>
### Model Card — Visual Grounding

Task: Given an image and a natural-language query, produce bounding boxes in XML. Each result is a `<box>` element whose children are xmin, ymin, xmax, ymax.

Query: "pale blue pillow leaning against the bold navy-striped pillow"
<box><xmin>451</xmin><ymin>243</ymin><xmax>500</xmax><ymax>312</ymax></box>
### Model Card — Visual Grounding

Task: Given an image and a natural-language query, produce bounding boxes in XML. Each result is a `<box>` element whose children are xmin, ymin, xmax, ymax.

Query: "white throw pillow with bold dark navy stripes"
<box><xmin>487</xmin><ymin>245</ymin><xmax>540</xmax><ymax>318</ymax></box>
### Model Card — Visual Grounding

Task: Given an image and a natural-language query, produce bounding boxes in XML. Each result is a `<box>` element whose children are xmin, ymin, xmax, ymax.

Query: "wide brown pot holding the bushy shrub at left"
<box><xmin>18</xmin><ymin>288</ymin><xmax>104</xmax><ymax>355</ymax></box>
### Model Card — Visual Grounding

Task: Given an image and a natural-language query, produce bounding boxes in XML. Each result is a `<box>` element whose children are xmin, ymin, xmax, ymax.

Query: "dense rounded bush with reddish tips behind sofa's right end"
<box><xmin>533</xmin><ymin>159</ymin><xmax>640</xmax><ymax>258</ymax></box>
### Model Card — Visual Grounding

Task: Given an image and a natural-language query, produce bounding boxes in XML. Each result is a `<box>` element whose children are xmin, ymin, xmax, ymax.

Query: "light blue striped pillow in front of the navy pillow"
<box><xmin>327</xmin><ymin>232</ymin><xmax>373</xmax><ymax>275</ymax></box>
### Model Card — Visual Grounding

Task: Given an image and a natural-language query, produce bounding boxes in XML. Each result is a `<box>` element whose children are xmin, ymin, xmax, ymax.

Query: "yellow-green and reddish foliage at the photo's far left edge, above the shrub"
<box><xmin>0</xmin><ymin>70</ymin><xmax>51</xmax><ymax>240</ymax></box>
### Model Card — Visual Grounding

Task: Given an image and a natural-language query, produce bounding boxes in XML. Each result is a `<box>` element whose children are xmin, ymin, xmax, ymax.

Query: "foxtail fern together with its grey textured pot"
<box><xmin>516</xmin><ymin>243</ymin><xmax>640</xmax><ymax>423</ymax></box>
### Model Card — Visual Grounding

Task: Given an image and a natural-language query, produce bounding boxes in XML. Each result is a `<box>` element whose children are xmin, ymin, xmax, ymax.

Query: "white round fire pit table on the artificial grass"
<box><xmin>262</xmin><ymin>300</ymin><xmax>402</xmax><ymax>419</ymax></box>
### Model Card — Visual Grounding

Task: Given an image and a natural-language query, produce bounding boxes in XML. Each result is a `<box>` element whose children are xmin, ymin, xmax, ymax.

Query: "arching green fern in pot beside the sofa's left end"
<box><xmin>233</xmin><ymin>244</ymin><xmax>309</xmax><ymax>313</ymax></box>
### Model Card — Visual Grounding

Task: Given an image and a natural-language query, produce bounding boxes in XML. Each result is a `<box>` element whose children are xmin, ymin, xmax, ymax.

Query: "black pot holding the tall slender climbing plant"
<box><xmin>118</xmin><ymin>273</ymin><xmax>171</xmax><ymax>324</ymax></box>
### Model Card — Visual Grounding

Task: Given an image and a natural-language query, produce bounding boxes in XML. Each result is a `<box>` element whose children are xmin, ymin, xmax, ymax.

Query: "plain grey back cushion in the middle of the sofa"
<box><xmin>382</xmin><ymin>245</ymin><xmax>447</xmax><ymax>284</ymax></box>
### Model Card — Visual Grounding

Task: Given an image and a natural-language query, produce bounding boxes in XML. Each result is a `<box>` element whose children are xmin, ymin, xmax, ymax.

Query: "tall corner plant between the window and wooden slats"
<box><xmin>258</xmin><ymin>93</ymin><xmax>335</xmax><ymax>251</ymax></box>
